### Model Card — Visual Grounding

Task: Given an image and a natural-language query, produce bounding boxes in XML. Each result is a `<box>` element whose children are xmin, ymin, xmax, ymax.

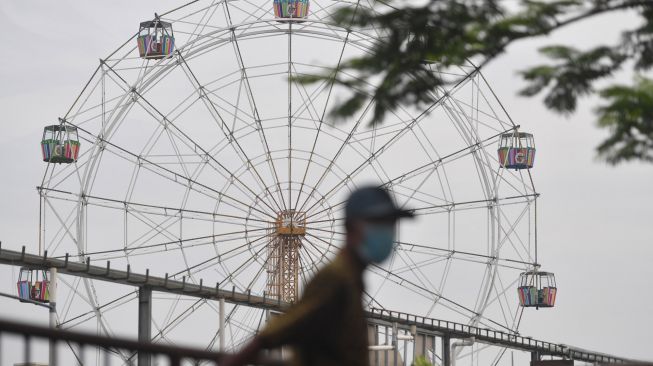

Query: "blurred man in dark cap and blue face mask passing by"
<box><xmin>220</xmin><ymin>187</ymin><xmax>413</xmax><ymax>366</ymax></box>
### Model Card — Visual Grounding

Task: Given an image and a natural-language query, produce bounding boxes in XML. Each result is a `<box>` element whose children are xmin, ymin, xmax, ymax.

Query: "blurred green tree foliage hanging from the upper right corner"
<box><xmin>300</xmin><ymin>0</ymin><xmax>653</xmax><ymax>164</ymax></box>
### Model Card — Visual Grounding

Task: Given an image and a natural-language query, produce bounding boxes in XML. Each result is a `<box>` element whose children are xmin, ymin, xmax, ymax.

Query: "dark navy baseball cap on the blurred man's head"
<box><xmin>345</xmin><ymin>186</ymin><xmax>414</xmax><ymax>220</ymax></box>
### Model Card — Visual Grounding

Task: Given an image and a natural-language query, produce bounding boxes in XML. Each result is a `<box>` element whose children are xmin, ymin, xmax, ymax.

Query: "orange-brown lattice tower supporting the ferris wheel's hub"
<box><xmin>267</xmin><ymin>210</ymin><xmax>306</xmax><ymax>302</ymax></box>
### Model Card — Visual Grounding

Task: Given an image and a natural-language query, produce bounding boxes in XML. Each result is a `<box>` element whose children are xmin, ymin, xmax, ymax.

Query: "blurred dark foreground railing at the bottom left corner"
<box><xmin>0</xmin><ymin>320</ymin><xmax>285</xmax><ymax>366</ymax></box>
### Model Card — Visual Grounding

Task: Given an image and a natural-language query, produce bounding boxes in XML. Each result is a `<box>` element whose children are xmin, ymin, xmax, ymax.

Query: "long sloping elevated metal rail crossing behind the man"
<box><xmin>0</xmin><ymin>245</ymin><xmax>632</xmax><ymax>366</ymax></box>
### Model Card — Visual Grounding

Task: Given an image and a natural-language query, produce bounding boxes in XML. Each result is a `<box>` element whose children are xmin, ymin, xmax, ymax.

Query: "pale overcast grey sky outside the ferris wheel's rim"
<box><xmin>0</xmin><ymin>0</ymin><xmax>653</xmax><ymax>360</ymax></box>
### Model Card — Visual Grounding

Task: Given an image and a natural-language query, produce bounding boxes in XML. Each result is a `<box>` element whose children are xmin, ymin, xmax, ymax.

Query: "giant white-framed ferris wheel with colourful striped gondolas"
<box><xmin>34</xmin><ymin>0</ymin><xmax>544</xmax><ymax>364</ymax></box>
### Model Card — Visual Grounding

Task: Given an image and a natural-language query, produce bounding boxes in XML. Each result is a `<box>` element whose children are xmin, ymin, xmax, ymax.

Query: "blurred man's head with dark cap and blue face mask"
<box><xmin>345</xmin><ymin>186</ymin><xmax>413</xmax><ymax>264</ymax></box>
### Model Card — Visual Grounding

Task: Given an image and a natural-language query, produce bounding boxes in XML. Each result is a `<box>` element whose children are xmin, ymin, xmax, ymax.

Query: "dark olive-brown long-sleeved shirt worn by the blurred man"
<box><xmin>258</xmin><ymin>253</ymin><xmax>370</xmax><ymax>366</ymax></box>
